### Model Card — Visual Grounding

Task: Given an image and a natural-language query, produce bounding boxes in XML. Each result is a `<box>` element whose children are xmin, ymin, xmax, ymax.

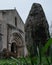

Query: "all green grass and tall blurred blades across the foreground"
<box><xmin>0</xmin><ymin>38</ymin><xmax>52</xmax><ymax>65</ymax></box>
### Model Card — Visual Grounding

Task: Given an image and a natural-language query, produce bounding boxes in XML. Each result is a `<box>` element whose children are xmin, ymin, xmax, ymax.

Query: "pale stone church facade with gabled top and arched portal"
<box><xmin>0</xmin><ymin>9</ymin><xmax>25</xmax><ymax>57</ymax></box>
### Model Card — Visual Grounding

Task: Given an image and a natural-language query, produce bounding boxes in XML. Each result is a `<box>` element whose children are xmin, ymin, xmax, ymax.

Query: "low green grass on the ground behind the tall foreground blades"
<box><xmin>0</xmin><ymin>57</ymin><xmax>51</xmax><ymax>65</ymax></box>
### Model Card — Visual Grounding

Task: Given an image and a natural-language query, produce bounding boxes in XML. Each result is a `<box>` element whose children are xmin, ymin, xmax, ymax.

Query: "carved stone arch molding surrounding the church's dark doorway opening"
<box><xmin>9</xmin><ymin>33</ymin><xmax>24</xmax><ymax>56</ymax></box>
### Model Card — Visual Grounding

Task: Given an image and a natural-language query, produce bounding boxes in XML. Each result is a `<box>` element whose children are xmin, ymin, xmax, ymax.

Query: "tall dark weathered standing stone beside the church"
<box><xmin>25</xmin><ymin>3</ymin><xmax>50</xmax><ymax>55</ymax></box>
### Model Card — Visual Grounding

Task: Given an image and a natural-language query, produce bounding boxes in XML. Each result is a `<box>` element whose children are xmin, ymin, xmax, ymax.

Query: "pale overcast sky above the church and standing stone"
<box><xmin>0</xmin><ymin>0</ymin><xmax>52</xmax><ymax>25</ymax></box>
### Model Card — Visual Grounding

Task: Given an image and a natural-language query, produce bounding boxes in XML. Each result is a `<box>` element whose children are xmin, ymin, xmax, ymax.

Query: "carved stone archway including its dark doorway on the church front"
<box><xmin>11</xmin><ymin>33</ymin><xmax>24</xmax><ymax>57</ymax></box>
